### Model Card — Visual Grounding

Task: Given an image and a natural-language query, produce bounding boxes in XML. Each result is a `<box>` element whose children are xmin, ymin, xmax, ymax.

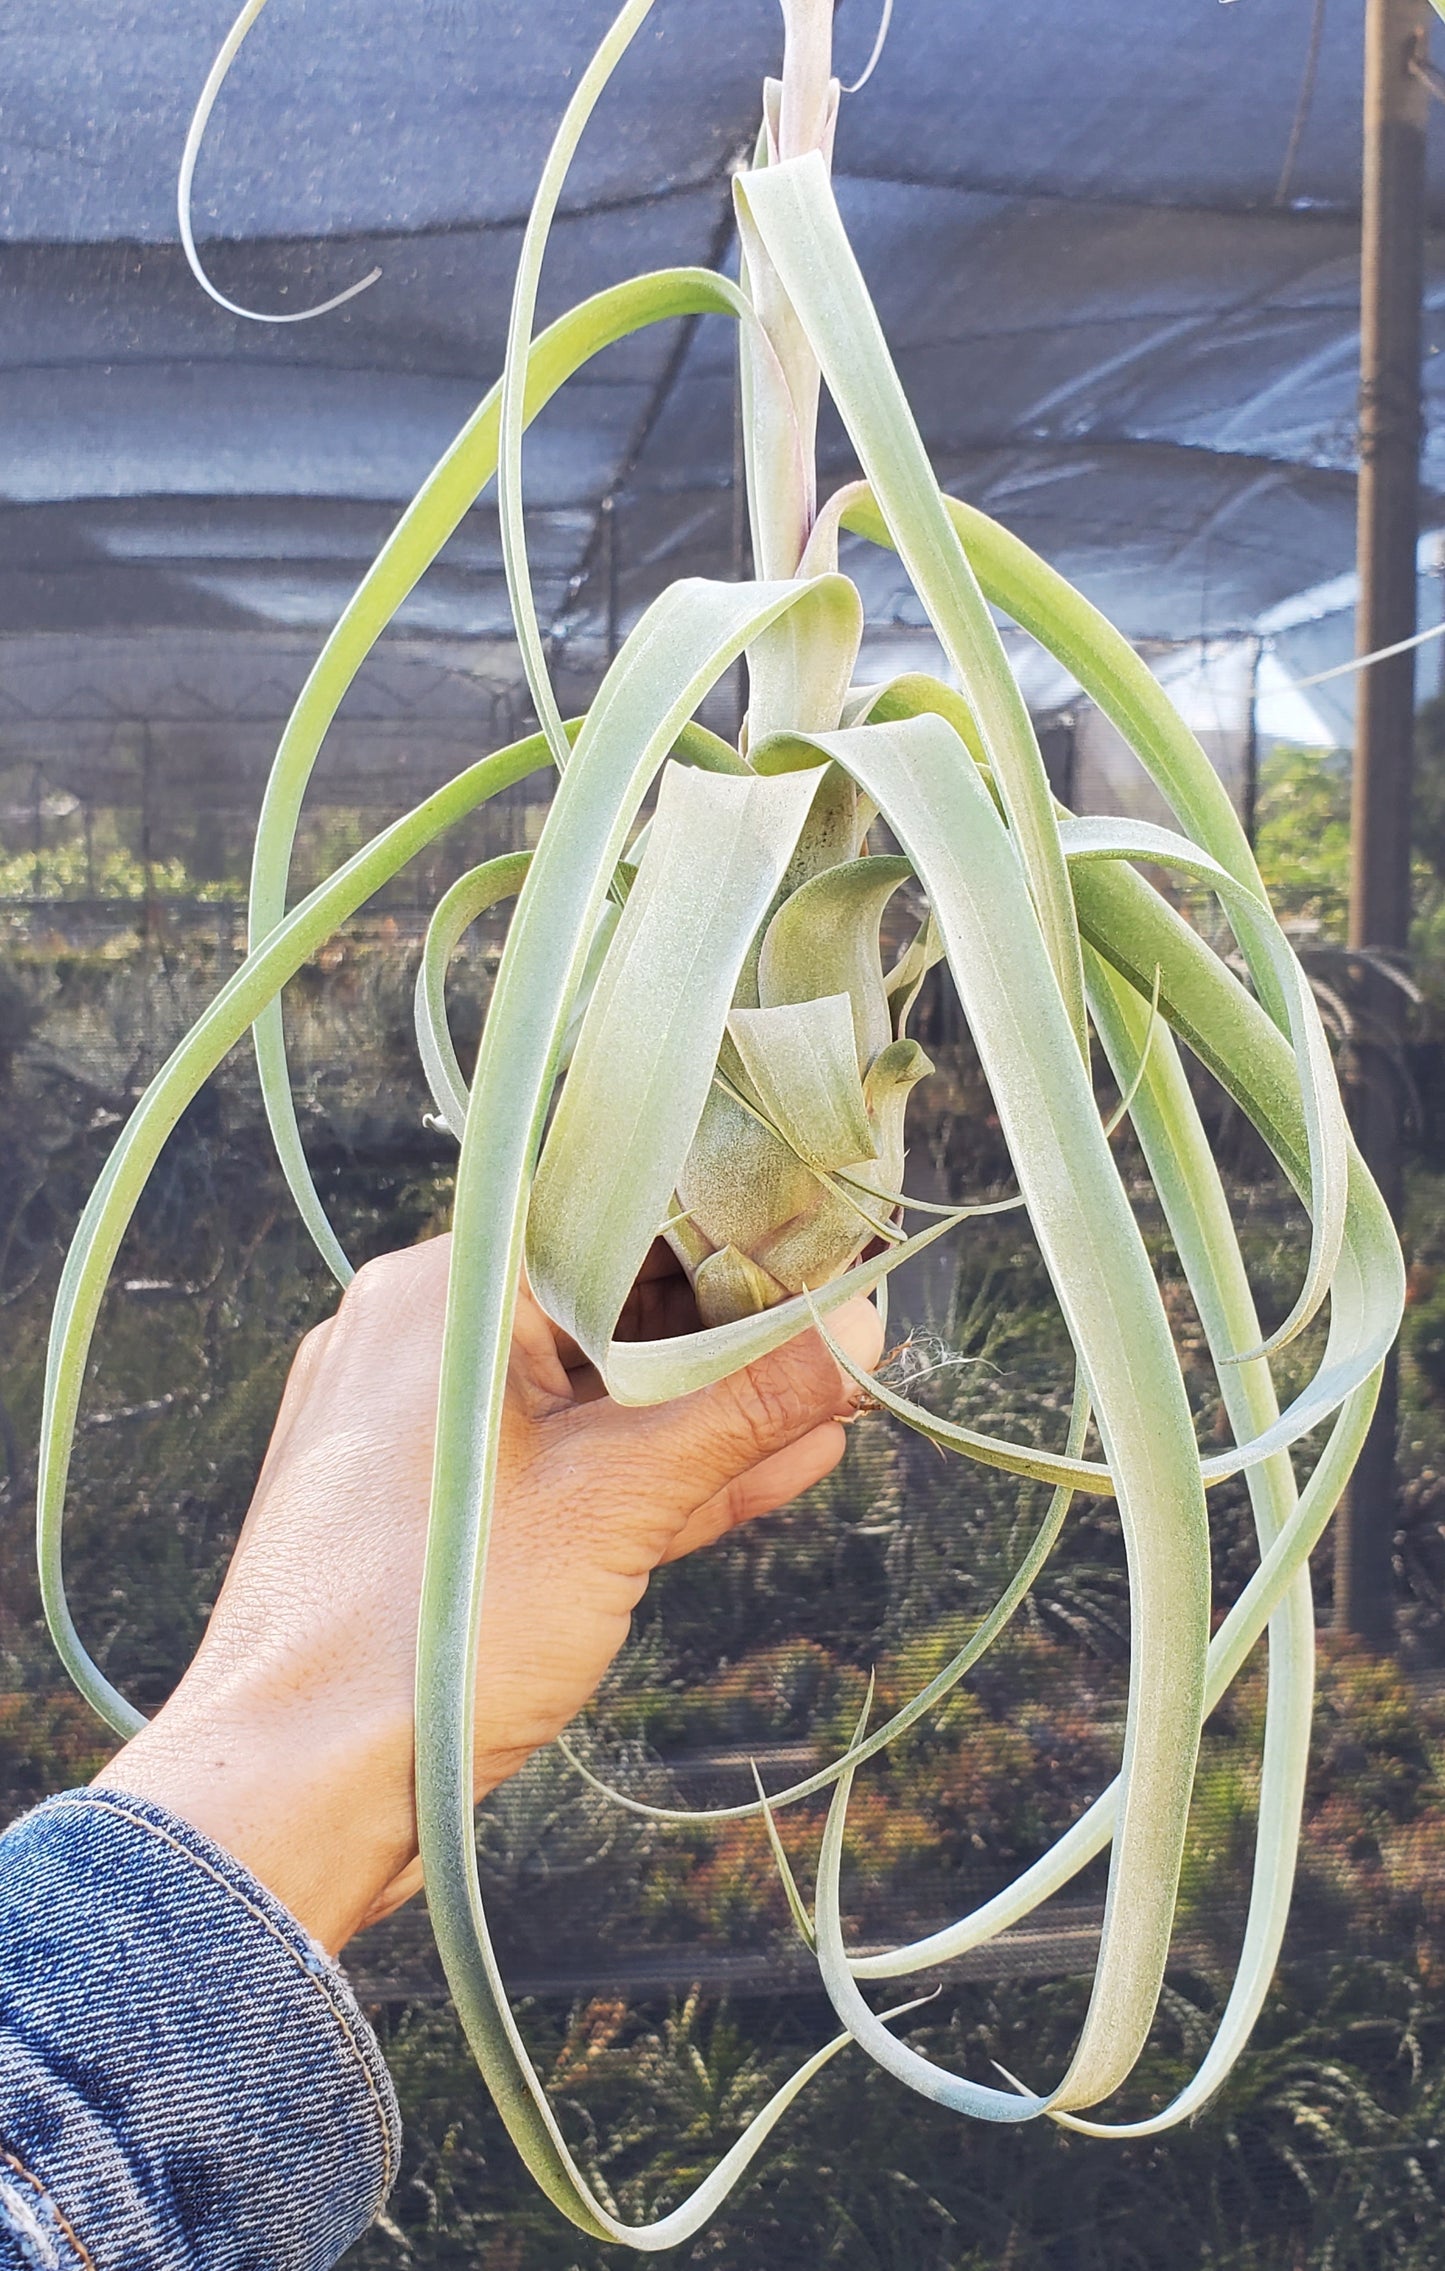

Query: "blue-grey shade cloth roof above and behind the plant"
<box><xmin>0</xmin><ymin>0</ymin><xmax>1445</xmax><ymax>717</ymax></box>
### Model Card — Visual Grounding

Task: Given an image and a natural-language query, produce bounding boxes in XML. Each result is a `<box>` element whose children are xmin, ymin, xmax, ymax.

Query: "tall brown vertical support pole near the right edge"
<box><xmin>1334</xmin><ymin>0</ymin><xmax>1429</xmax><ymax>1649</ymax></box>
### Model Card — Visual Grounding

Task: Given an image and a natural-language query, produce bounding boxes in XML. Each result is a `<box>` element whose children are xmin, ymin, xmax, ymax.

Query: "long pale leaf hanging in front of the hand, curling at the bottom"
<box><xmin>416</xmin><ymin>577</ymin><xmax>936</xmax><ymax>2251</ymax></box>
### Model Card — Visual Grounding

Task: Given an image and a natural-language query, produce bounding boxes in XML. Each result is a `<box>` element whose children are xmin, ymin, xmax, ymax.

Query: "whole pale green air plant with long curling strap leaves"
<box><xmin>39</xmin><ymin>0</ymin><xmax>1402</xmax><ymax>2248</ymax></box>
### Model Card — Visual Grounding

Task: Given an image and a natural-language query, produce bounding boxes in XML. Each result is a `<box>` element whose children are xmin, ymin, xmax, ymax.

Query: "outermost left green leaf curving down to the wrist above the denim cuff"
<box><xmin>36</xmin><ymin>734</ymin><xmax>558</xmax><ymax>1735</ymax></box>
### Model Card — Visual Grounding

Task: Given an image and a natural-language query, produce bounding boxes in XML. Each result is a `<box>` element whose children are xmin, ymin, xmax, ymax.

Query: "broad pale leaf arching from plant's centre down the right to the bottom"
<box><xmin>759</xmin><ymin>718</ymin><xmax>1209</xmax><ymax>2105</ymax></box>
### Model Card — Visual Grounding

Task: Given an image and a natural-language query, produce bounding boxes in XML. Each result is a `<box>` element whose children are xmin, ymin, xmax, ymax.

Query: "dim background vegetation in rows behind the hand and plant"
<box><xmin>0</xmin><ymin>711</ymin><xmax>1445</xmax><ymax>2271</ymax></box>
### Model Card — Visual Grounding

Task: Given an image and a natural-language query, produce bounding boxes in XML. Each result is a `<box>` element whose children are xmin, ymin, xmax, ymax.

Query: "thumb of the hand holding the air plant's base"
<box><xmin>627</xmin><ymin>1299</ymin><xmax>884</xmax><ymax>1515</ymax></box>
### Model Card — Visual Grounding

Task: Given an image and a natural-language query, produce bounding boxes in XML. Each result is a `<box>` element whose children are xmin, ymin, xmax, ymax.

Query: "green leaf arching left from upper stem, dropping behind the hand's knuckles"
<box><xmin>248</xmin><ymin>268</ymin><xmax>747</xmax><ymax>1285</ymax></box>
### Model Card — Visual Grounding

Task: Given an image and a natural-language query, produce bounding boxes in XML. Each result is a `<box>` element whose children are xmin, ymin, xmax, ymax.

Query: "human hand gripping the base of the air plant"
<box><xmin>98</xmin><ymin>1238</ymin><xmax>882</xmax><ymax>1951</ymax></box>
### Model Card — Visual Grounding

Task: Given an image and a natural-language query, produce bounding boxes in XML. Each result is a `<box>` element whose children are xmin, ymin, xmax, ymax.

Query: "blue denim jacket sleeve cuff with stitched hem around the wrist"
<box><xmin>0</xmin><ymin>1790</ymin><xmax>400</xmax><ymax>2271</ymax></box>
